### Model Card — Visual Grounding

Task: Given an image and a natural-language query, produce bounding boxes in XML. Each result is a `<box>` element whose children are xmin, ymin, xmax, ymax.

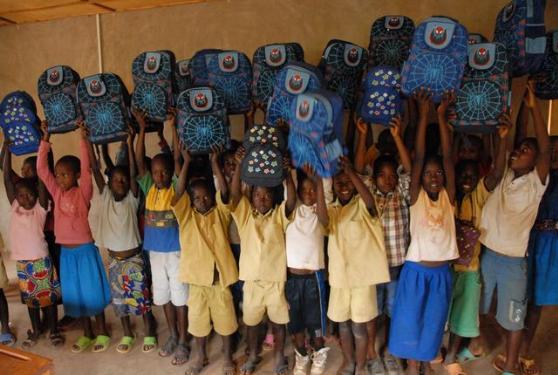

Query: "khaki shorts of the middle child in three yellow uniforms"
<box><xmin>242</xmin><ymin>281</ymin><xmax>289</xmax><ymax>326</ymax></box>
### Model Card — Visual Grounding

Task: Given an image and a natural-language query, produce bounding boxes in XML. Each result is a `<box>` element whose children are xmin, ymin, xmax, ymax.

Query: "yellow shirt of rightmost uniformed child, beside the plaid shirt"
<box><xmin>328</xmin><ymin>195</ymin><xmax>390</xmax><ymax>288</ymax></box>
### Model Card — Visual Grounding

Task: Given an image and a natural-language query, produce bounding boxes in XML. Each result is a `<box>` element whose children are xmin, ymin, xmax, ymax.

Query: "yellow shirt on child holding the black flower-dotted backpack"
<box><xmin>232</xmin><ymin>197</ymin><xmax>289</xmax><ymax>282</ymax></box>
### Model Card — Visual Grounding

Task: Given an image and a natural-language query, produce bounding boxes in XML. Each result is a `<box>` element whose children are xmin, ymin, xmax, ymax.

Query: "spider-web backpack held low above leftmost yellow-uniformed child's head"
<box><xmin>176</xmin><ymin>87</ymin><xmax>230</xmax><ymax>154</ymax></box>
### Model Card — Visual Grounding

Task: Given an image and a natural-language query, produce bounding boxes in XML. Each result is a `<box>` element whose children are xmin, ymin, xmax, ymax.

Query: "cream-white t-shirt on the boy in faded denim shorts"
<box><xmin>480</xmin><ymin>169</ymin><xmax>548</xmax><ymax>257</ymax></box>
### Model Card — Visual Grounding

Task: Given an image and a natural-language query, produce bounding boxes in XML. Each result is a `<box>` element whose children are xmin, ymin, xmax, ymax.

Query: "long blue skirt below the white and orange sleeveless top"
<box><xmin>389</xmin><ymin>262</ymin><xmax>452</xmax><ymax>361</ymax></box>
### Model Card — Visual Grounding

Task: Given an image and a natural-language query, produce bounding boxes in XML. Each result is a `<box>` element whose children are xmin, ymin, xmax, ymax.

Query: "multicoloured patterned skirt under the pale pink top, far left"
<box><xmin>16</xmin><ymin>256</ymin><xmax>60</xmax><ymax>308</ymax></box>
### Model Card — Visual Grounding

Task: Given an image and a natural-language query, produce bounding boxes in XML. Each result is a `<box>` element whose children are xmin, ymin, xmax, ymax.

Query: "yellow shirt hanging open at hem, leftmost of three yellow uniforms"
<box><xmin>173</xmin><ymin>193</ymin><xmax>238</xmax><ymax>286</ymax></box>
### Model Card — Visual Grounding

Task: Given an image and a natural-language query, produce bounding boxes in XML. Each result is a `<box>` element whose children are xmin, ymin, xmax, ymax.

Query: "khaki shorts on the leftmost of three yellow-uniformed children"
<box><xmin>188</xmin><ymin>284</ymin><xmax>238</xmax><ymax>337</ymax></box>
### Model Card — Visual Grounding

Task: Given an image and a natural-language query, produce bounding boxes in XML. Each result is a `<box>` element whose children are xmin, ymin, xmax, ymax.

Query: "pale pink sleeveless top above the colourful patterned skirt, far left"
<box><xmin>8</xmin><ymin>203</ymin><xmax>48</xmax><ymax>260</ymax></box>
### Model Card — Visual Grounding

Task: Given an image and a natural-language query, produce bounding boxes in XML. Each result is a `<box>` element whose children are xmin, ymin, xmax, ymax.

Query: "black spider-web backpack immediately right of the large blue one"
<box><xmin>456</xmin><ymin>43</ymin><xmax>511</xmax><ymax>133</ymax></box>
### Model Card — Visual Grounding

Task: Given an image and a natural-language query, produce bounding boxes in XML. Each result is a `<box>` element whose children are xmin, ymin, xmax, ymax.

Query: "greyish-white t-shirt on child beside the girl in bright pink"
<box><xmin>89</xmin><ymin>186</ymin><xmax>141</xmax><ymax>251</ymax></box>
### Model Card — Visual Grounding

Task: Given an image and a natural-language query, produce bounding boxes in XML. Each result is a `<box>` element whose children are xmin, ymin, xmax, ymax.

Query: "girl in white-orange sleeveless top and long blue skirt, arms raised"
<box><xmin>389</xmin><ymin>90</ymin><xmax>459</xmax><ymax>375</ymax></box>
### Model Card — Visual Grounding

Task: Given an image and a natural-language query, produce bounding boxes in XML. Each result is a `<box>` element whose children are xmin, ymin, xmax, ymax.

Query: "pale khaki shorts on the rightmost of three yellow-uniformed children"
<box><xmin>327</xmin><ymin>285</ymin><xmax>378</xmax><ymax>323</ymax></box>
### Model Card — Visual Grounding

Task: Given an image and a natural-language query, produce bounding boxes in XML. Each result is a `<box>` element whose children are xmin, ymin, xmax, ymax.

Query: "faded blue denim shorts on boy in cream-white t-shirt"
<box><xmin>480</xmin><ymin>246</ymin><xmax>527</xmax><ymax>331</ymax></box>
